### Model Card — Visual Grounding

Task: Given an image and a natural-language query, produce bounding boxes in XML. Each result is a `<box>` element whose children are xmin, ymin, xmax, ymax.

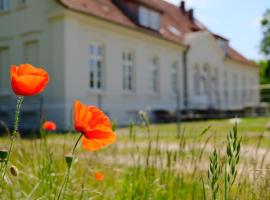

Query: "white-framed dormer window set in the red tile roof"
<box><xmin>139</xmin><ymin>6</ymin><xmax>160</xmax><ymax>31</ymax></box>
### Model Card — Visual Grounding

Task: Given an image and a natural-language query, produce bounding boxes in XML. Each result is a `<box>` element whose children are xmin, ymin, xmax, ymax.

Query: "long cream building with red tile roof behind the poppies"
<box><xmin>0</xmin><ymin>0</ymin><xmax>259</xmax><ymax>129</ymax></box>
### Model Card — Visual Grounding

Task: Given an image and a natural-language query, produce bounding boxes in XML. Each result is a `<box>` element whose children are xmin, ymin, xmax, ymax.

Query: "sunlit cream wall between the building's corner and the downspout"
<box><xmin>65</xmin><ymin>11</ymin><xmax>184</xmax><ymax>124</ymax></box>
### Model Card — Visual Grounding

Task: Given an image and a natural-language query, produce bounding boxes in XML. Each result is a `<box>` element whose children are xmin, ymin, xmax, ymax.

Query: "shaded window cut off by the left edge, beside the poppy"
<box><xmin>0</xmin><ymin>47</ymin><xmax>10</xmax><ymax>95</ymax></box>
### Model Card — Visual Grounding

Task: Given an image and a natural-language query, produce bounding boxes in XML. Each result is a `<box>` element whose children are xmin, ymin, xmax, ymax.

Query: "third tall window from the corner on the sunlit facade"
<box><xmin>149</xmin><ymin>58</ymin><xmax>159</xmax><ymax>93</ymax></box>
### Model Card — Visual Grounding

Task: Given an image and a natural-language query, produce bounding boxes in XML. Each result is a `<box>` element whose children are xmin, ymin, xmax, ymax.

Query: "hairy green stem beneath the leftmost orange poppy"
<box><xmin>0</xmin><ymin>96</ymin><xmax>24</xmax><ymax>185</ymax></box>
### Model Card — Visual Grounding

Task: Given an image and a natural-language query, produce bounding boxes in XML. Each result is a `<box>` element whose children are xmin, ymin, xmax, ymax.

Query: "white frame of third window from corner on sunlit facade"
<box><xmin>149</xmin><ymin>56</ymin><xmax>159</xmax><ymax>95</ymax></box>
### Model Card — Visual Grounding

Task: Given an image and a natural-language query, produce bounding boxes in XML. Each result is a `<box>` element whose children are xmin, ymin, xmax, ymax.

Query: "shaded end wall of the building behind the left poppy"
<box><xmin>0</xmin><ymin>0</ymin><xmax>65</xmax><ymax>127</ymax></box>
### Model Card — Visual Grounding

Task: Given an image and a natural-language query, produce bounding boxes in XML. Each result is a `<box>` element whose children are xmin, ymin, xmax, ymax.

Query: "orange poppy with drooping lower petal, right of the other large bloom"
<box><xmin>74</xmin><ymin>101</ymin><xmax>116</xmax><ymax>151</ymax></box>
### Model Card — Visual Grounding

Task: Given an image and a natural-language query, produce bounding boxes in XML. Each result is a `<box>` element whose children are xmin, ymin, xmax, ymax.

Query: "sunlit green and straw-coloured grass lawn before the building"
<box><xmin>0</xmin><ymin>118</ymin><xmax>270</xmax><ymax>200</ymax></box>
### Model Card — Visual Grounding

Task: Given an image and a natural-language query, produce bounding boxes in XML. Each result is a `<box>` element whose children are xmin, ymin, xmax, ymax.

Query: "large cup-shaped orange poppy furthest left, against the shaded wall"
<box><xmin>10</xmin><ymin>64</ymin><xmax>49</xmax><ymax>96</ymax></box>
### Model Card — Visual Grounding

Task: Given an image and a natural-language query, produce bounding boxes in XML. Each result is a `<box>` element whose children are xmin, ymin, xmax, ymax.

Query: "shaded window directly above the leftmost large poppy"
<box><xmin>24</xmin><ymin>40</ymin><xmax>39</xmax><ymax>66</ymax></box>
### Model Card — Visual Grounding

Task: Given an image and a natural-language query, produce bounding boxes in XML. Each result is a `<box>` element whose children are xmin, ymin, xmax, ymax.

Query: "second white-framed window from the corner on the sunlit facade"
<box><xmin>122</xmin><ymin>51</ymin><xmax>134</xmax><ymax>92</ymax></box>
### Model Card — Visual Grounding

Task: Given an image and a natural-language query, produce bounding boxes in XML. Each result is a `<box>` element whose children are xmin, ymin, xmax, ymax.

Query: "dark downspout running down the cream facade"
<box><xmin>183</xmin><ymin>46</ymin><xmax>190</xmax><ymax>110</ymax></box>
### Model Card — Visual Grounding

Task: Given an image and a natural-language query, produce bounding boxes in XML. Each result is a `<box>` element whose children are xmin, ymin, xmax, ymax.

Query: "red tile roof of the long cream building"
<box><xmin>58</xmin><ymin>0</ymin><xmax>255</xmax><ymax>66</ymax></box>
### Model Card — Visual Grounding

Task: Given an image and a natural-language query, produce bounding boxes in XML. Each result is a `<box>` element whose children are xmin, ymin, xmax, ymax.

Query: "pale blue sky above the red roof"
<box><xmin>166</xmin><ymin>0</ymin><xmax>270</xmax><ymax>59</ymax></box>
